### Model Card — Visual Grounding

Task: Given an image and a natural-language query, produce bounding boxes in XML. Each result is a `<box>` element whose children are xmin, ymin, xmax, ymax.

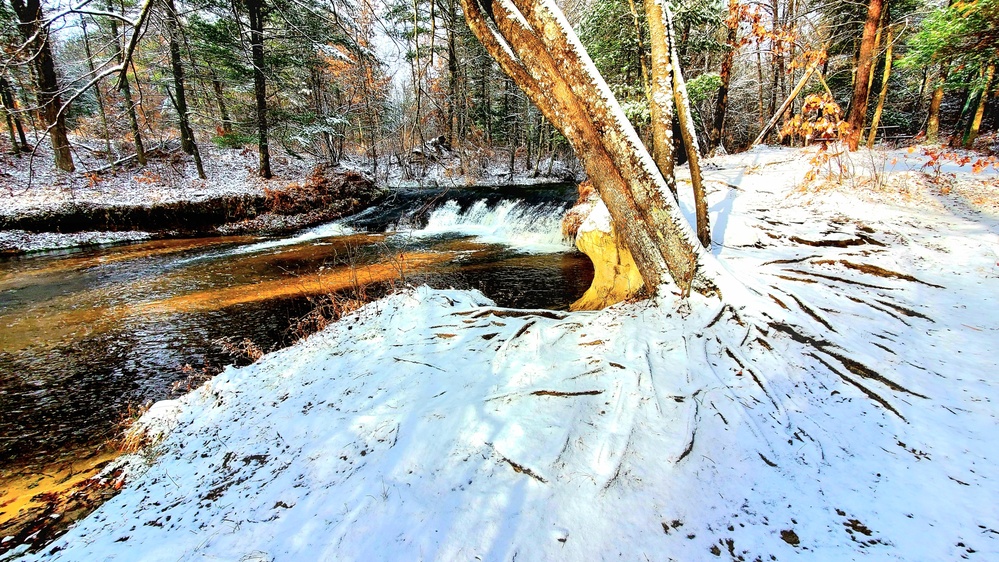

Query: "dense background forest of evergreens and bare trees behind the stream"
<box><xmin>0</xmin><ymin>0</ymin><xmax>999</xmax><ymax>185</ymax></box>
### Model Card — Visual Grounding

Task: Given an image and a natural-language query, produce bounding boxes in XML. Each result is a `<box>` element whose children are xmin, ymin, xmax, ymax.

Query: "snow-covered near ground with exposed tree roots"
<box><xmin>7</xmin><ymin>148</ymin><xmax>999</xmax><ymax>561</ymax></box>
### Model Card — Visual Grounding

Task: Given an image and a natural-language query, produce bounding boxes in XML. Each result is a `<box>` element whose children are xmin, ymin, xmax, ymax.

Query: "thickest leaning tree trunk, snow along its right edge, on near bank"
<box><xmin>462</xmin><ymin>0</ymin><xmax>717</xmax><ymax>295</ymax></box>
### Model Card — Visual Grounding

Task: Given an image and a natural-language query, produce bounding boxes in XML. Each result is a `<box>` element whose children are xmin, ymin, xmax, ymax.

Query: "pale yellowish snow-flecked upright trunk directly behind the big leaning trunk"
<box><xmin>645</xmin><ymin>0</ymin><xmax>678</xmax><ymax>199</ymax></box>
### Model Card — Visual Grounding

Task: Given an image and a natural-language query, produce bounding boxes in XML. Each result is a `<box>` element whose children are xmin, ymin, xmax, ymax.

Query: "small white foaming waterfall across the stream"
<box><xmin>396</xmin><ymin>199</ymin><xmax>571</xmax><ymax>249</ymax></box>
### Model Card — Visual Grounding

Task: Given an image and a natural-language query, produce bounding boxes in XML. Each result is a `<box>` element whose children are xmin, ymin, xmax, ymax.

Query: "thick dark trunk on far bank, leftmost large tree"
<box><xmin>10</xmin><ymin>0</ymin><xmax>76</xmax><ymax>172</ymax></box>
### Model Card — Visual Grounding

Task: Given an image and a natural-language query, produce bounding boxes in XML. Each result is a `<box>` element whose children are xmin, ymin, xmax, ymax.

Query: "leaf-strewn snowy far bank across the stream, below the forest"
<box><xmin>0</xmin><ymin>141</ymin><xmax>577</xmax><ymax>254</ymax></box>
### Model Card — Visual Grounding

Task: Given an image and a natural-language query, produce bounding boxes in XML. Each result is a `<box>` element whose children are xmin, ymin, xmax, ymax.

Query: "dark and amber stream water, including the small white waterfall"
<box><xmin>0</xmin><ymin>186</ymin><xmax>593</xmax><ymax>476</ymax></box>
